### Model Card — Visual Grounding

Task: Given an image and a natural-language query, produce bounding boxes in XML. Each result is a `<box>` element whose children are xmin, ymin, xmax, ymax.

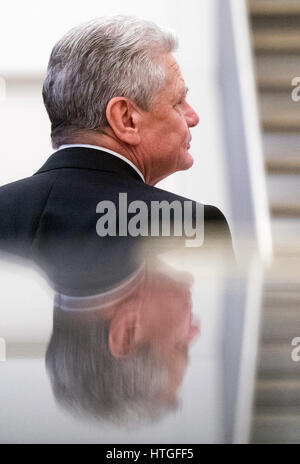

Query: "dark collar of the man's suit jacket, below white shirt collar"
<box><xmin>34</xmin><ymin>147</ymin><xmax>143</xmax><ymax>182</ymax></box>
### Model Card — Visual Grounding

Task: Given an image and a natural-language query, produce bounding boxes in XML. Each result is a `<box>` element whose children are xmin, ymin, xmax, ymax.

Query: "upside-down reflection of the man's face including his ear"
<box><xmin>108</xmin><ymin>268</ymin><xmax>199</xmax><ymax>402</ymax></box>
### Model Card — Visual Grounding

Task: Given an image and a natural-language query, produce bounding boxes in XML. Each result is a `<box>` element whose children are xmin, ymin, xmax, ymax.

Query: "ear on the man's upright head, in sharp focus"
<box><xmin>106</xmin><ymin>97</ymin><xmax>141</xmax><ymax>145</ymax></box>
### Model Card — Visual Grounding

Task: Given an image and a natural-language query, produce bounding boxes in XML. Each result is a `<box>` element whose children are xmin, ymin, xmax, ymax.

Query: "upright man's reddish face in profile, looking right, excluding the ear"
<box><xmin>141</xmin><ymin>54</ymin><xmax>199</xmax><ymax>183</ymax></box>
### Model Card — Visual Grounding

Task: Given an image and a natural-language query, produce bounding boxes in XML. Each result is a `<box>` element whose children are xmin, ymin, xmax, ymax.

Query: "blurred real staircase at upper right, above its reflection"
<box><xmin>248</xmin><ymin>0</ymin><xmax>300</xmax><ymax>254</ymax></box>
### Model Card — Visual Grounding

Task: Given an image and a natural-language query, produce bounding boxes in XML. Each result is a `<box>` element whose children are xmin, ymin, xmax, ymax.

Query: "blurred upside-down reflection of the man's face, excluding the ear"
<box><xmin>141</xmin><ymin>271</ymin><xmax>199</xmax><ymax>396</ymax></box>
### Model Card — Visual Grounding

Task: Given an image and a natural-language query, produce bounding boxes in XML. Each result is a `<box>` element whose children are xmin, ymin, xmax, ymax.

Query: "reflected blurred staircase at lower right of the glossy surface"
<box><xmin>251</xmin><ymin>256</ymin><xmax>300</xmax><ymax>443</ymax></box>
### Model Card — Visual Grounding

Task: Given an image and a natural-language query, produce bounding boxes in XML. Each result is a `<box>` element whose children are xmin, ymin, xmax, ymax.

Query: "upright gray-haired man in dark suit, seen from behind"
<box><xmin>0</xmin><ymin>16</ymin><xmax>230</xmax><ymax>286</ymax></box>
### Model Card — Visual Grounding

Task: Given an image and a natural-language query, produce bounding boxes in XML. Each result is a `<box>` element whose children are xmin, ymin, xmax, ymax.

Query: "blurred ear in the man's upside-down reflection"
<box><xmin>108</xmin><ymin>308</ymin><xmax>141</xmax><ymax>359</ymax></box>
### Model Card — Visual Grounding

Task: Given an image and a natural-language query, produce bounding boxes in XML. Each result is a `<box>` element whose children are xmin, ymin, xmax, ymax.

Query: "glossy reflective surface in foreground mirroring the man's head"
<box><xmin>0</xmin><ymin>248</ymin><xmax>300</xmax><ymax>444</ymax></box>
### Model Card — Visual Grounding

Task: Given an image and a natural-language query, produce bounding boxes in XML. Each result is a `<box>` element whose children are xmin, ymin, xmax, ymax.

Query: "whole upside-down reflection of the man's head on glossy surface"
<box><xmin>46</xmin><ymin>265</ymin><xmax>198</xmax><ymax>422</ymax></box>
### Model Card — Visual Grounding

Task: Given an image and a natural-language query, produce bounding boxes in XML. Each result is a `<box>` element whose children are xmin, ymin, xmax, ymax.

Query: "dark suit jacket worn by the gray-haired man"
<box><xmin>0</xmin><ymin>147</ymin><xmax>231</xmax><ymax>294</ymax></box>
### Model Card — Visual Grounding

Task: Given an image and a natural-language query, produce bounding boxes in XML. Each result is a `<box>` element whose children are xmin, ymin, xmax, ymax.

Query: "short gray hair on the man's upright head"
<box><xmin>43</xmin><ymin>16</ymin><xmax>177</xmax><ymax>148</ymax></box>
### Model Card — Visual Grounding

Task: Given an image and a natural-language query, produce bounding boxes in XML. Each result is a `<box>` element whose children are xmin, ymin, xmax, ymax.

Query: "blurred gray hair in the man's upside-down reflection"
<box><xmin>46</xmin><ymin>308</ymin><xmax>178</xmax><ymax>425</ymax></box>
